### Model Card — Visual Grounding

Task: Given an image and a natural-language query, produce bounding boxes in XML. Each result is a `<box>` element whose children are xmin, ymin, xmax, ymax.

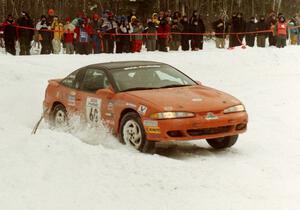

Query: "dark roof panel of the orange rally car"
<box><xmin>88</xmin><ymin>61</ymin><xmax>166</xmax><ymax>70</ymax></box>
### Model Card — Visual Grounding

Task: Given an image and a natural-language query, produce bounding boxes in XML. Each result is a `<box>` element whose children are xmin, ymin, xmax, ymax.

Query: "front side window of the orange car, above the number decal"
<box><xmin>81</xmin><ymin>69</ymin><xmax>109</xmax><ymax>92</ymax></box>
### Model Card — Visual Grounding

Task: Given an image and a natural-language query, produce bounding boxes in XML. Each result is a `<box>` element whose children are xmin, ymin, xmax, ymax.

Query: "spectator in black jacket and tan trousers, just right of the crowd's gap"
<box><xmin>212</xmin><ymin>16</ymin><xmax>228</xmax><ymax>49</ymax></box>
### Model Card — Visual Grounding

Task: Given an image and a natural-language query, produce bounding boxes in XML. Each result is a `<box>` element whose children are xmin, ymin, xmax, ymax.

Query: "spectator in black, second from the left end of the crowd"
<box><xmin>17</xmin><ymin>12</ymin><xmax>34</xmax><ymax>55</ymax></box>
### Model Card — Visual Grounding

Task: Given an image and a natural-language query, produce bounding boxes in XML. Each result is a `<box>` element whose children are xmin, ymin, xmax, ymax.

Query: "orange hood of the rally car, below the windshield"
<box><xmin>127</xmin><ymin>85</ymin><xmax>241</xmax><ymax>112</ymax></box>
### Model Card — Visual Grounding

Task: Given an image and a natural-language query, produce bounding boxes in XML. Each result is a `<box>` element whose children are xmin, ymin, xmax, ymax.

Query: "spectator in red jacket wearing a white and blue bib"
<box><xmin>75</xmin><ymin>19</ymin><xmax>93</xmax><ymax>55</ymax></box>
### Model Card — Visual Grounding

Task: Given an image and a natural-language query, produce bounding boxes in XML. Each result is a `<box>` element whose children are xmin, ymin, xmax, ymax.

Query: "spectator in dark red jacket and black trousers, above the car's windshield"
<box><xmin>157</xmin><ymin>18</ymin><xmax>171</xmax><ymax>52</ymax></box>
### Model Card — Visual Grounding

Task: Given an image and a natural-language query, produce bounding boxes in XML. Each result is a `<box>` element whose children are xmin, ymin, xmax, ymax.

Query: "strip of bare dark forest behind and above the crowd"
<box><xmin>0</xmin><ymin>0</ymin><xmax>300</xmax><ymax>22</ymax></box>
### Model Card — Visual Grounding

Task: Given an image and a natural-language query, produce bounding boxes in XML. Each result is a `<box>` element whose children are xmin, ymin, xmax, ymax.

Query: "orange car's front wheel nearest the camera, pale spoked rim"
<box><xmin>119</xmin><ymin>112</ymin><xmax>155</xmax><ymax>153</ymax></box>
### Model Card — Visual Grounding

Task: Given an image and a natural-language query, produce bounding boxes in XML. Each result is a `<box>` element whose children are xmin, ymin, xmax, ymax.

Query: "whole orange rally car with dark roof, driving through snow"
<box><xmin>43</xmin><ymin>61</ymin><xmax>248</xmax><ymax>152</ymax></box>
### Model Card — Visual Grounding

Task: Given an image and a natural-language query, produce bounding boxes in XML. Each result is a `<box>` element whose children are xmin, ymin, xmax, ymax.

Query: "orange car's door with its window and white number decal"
<box><xmin>78</xmin><ymin>68</ymin><xmax>110</xmax><ymax>125</ymax></box>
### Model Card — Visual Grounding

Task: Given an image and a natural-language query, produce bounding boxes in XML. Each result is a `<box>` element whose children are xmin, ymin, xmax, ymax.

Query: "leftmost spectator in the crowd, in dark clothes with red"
<box><xmin>3</xmin><ymin>15</ymin><xmax>17</xmax><ymax>55</ymax></box>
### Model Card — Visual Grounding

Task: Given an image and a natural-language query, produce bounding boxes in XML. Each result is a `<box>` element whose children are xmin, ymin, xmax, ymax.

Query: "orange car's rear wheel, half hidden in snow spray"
<box><xmin>51</xmin><ymin>104</ymin><xmax>69</xmax><ymax>128</ymax></box>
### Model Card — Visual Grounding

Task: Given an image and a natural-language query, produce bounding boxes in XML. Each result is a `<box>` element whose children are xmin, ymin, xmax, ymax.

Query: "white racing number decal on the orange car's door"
<box><xmin>86</xmin><ymin>97</ymin><xmax>101</xmax><ymax>124</ymax></box>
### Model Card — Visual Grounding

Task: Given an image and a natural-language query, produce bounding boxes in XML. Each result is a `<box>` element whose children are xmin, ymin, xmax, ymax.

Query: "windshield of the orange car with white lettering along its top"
<box><xmin>112</xmin><ymin>64</ymin><xmax>196</xmax><ymax>92</ymax></box>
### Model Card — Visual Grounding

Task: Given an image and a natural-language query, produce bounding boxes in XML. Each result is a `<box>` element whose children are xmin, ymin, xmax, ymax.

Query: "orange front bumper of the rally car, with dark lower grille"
<box><xmin>143</xmin><ymin>112</ymin><xmax>248</xmax><ymax>141</ymax></box>
